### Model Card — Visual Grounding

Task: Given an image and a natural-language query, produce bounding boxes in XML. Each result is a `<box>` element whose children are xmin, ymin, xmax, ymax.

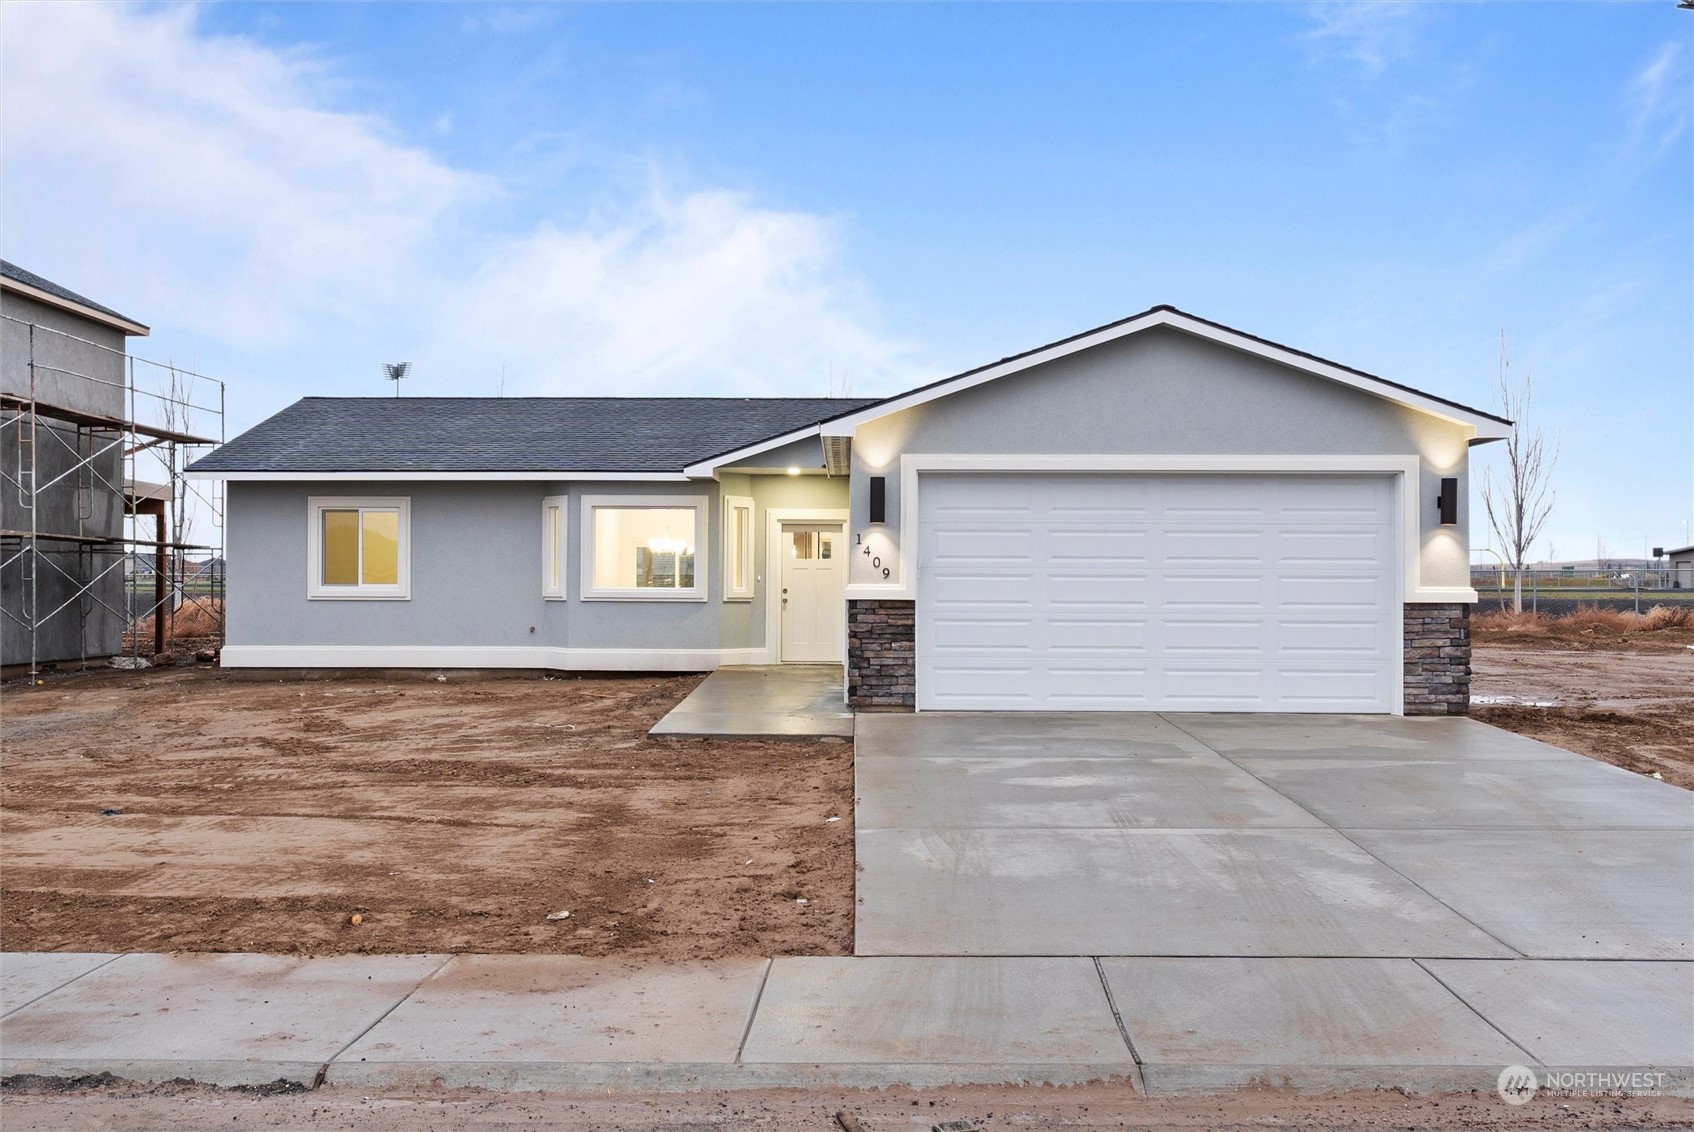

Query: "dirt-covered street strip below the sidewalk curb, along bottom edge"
<box><xmin>3</xmin><ymin>1083</ymin><xmax>1694</xmax><ymax>1132</ymax></box>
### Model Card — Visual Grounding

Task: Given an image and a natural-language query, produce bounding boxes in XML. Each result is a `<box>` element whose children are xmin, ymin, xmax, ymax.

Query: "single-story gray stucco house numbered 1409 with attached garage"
<box><xmin>191</xmin><ymin>307</ymin><xmax>1509</xmax><ymax>713</ymax></box>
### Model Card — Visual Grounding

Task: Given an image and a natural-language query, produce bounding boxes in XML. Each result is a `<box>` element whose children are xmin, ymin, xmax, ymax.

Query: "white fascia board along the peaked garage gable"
<box><xmin>823</xmin><ymin>310</ymin><xmax>1511</xmax><ymax>441</ymax></box>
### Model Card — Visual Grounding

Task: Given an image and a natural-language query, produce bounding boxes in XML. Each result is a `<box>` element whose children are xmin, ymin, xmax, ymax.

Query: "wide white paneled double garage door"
<box><xmin>916</xmin><ymin>473</ymin><xmax>1401</xmax><ymax>712</ymax></box>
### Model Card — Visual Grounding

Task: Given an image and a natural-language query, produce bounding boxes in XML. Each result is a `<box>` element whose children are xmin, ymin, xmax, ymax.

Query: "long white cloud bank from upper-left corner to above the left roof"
<box><xmin>0</xmin><ymin>3</ymin><xmax>903</xmax><ymax>393</ymax></box>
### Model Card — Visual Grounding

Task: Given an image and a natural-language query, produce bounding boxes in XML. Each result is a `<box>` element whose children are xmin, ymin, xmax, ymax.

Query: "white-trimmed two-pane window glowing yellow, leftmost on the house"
<box><xmin>307</xmin><ymin>497</ymin><xmax>412</xmax><ymax>598</ymax></box>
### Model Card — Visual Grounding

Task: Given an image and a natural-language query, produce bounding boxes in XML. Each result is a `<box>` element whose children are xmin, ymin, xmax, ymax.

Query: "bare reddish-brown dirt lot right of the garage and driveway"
<box><xmin>1470</xmin><ymin>610</ymin><xmax>1694</xmax><ymax>790</ymax></box>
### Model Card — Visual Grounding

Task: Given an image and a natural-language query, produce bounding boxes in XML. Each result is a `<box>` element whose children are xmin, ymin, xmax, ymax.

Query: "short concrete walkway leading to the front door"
<box><xmin>647</xmin><ymin>664</ymin><xmax>854</xmax><ymax>739</ymax></box>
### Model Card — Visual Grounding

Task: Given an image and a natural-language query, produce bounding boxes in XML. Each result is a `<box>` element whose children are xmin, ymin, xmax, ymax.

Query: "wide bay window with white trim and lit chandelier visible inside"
<box><xmin>583</xmin><ymin>497</ymin><xmax>706</xmax><ymax>602</ymax></box>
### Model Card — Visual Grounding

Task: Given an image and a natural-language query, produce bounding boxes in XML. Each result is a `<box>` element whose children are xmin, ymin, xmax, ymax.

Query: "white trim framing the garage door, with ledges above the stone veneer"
<box><xmin>847</xmin><ymin>452</ymin><xmax>1479</xmax><ymax>605</ymax></box>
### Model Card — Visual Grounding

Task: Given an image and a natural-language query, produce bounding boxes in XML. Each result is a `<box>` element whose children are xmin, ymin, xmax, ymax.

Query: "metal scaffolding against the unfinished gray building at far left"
<box><xmin>0</xmin><ymin>315</ymin><xmax>224</xmax><ymax>674</ymax></box>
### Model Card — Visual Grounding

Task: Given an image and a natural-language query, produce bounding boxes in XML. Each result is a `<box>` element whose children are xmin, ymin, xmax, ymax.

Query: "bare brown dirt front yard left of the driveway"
<box><xmin>0</xmin><ymin>668</ymin><xmax>854</xmax><ymax>961</ymax></box>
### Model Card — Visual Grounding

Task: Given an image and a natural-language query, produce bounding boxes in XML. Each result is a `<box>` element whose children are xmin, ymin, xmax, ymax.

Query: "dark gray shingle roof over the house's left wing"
<box><xmin>191</xmin><ymin>397</ymin><xmax>874</xmax><ymax>473</ymax></box>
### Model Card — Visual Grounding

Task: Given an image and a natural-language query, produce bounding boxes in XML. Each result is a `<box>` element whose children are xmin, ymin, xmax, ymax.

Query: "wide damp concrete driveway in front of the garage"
<box><xmin>855</xmin><ymin>713</ymin><xmax>1694</xmax><ymax>961</ymax></box>
